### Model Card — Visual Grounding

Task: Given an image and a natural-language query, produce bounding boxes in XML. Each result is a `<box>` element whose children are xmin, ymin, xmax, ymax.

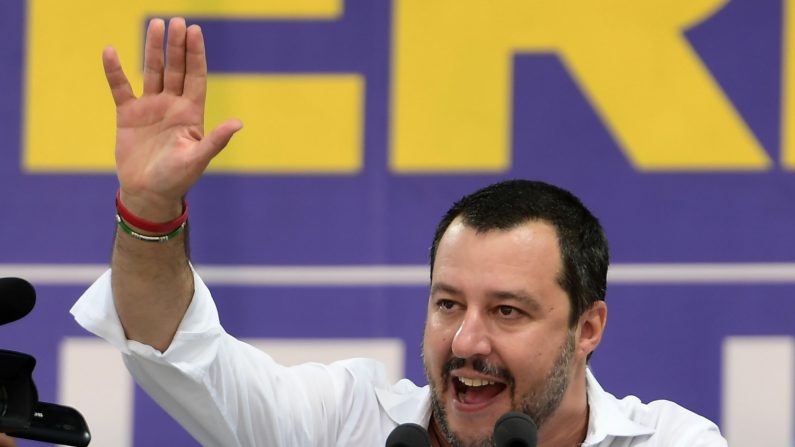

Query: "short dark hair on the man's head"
<box><xmin>431</xmin><ymin>180</ymin><xmax>609</xmax><ymax>327</ymax></box>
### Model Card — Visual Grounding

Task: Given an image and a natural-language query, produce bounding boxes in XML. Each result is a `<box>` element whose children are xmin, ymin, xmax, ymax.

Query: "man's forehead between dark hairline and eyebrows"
<box><xmin>433</xmin><ymin>219</ymin><xmax>562</xmax><ymax>292</ymax></box>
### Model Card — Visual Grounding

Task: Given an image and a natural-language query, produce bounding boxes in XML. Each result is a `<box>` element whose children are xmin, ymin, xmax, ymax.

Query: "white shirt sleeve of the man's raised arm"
<box><xmin>71</xmin><ymin>270</ymin><xmax>383</xmax><ymax>446</ymax></box>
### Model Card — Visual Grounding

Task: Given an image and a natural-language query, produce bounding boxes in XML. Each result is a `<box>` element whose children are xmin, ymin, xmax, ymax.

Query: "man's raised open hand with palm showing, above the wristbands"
<box><xmin>102</xmin><ymin>18</ymin><xmax>242</xmax><ymax>222</ymax></box>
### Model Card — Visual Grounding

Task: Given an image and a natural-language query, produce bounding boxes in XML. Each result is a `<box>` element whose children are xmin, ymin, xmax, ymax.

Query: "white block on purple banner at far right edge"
<box><xmin>721</xmin><ymin>336</ymin><xmax>795</xmax><ymax>447</ymax></box>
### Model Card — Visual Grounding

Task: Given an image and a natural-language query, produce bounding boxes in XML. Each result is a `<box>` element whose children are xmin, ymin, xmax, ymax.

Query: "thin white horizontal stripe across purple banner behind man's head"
<box><xmin>0</xmin><ymin>263</ymin><xmax>795</xmax><ymax>286</ymax></box>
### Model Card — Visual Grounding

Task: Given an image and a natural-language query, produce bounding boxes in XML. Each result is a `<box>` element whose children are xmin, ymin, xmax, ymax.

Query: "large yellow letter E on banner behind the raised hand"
<box><xmin>23</xmin><ymin>0</ymin><xmax>364</xmax><ymax>172</ymax></box>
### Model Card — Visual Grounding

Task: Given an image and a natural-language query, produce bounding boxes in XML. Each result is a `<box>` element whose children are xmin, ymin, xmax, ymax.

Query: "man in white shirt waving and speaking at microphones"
<box><xmin>72</xmin><ymin>18</ymin><xmax>726</xmax><ymax>447</ymax></box>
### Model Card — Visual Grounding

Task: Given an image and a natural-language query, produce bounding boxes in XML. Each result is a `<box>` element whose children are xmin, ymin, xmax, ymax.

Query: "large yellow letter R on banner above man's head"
<box><xmin>390</xmin><ymin>0</ymin><xmax>770</xmax><ymax>172</ymax></box>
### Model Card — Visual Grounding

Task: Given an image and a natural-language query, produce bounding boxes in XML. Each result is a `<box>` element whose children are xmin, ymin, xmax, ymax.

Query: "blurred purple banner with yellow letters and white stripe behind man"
<box><xmin>0</xmin><ymin>0</ymin><xmax>795</xmax><ymax>447</ymax></box>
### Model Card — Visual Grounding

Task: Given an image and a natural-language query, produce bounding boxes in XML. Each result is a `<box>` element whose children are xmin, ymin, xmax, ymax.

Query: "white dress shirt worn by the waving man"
<box><xmin>71</xmin><ymin>270</ymin><xmax>726</xmax><ymax>447</ymax></box>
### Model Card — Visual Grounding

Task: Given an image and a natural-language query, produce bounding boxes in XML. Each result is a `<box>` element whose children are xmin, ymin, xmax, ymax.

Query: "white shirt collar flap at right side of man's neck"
<box><xmin>583</xmin><ymin>368</ymin><xmax>654</xmax><ymax>446</ymax></box>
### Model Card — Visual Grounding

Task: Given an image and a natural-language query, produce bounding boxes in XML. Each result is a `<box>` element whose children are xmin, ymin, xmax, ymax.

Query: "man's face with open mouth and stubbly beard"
<box><xmin>423</xmin><ymin>220</ymin><xmax>575</xmax><ymax>445</ymax></box>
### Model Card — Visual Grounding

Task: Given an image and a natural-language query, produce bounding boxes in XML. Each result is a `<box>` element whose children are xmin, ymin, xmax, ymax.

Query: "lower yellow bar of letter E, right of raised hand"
<box><xmin>205</xmin><ymin>75</ymin><xmax>364</xmax><ymax>173</ymax></box>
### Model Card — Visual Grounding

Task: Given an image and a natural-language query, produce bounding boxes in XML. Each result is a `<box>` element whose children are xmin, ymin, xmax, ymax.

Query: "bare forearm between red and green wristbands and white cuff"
<box><xmin>111</xmin><ymin>224</ymin><xmax>194</xmax><ymax>352</ymax></box>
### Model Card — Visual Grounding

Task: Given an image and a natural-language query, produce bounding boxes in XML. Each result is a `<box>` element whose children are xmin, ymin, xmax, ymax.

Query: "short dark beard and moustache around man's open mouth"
<box><xmin>423</xmin><ymin>329</ymin><xmax>574</xmax><ymax>447</ymax></box>
